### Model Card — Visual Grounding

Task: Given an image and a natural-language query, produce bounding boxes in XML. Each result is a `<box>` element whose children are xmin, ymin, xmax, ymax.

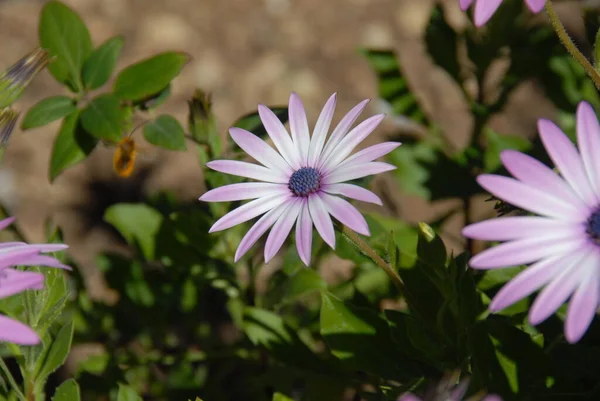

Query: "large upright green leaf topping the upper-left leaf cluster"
<box><xmin>39</xmin><ymin>1</ymin><xmax>92</xmax><ymax>92</ymax></box>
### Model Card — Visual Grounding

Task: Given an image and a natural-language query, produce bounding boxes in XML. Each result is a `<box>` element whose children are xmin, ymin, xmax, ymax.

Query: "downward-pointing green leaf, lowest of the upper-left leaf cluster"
<box><xmin>49</xmin><ymin>111</ymin><xmax>97</xmax><ymax>182</ymax></box>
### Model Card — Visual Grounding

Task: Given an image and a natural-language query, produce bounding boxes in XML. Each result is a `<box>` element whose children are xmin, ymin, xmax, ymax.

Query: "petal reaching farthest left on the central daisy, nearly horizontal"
<box><xmin>200</xmin><ymin>182</ymin><xmax>290</xmax><ymax>202</ymax></box>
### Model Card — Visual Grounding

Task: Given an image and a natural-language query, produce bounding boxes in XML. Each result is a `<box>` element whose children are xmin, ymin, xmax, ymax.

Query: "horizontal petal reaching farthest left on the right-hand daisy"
<box><xmin>462</xmin><ymin>216</ymin><xmax>586</xmax><ymax>241</ymax></box>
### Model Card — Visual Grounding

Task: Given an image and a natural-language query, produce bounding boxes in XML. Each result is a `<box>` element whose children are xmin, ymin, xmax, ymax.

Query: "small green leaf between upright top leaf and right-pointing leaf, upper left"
<box><xmin>81</xmin><ymin>36</ymin><xmax>124</xmax><ymax>89</ymax></box>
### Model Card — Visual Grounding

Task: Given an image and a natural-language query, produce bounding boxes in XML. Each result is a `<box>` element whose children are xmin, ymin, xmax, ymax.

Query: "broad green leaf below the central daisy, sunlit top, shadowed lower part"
<box><xmin>320</xmin><ymin>292</ymin><xmax>406</xmax><ymax>379</ymax></box>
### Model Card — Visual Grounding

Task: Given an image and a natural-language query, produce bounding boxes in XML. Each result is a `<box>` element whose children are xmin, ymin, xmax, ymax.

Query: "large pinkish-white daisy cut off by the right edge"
<box><xmin>463</xmin><ymin>102</ymin><xmax>600</xmax><ymax>343</ymax></box>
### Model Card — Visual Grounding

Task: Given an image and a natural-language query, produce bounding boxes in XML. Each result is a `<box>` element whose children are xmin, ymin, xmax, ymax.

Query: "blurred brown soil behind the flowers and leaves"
<box><xmin>0</xmin><ymin>0</ymin><xmax>581</xmax><ymax>298</ymax></box>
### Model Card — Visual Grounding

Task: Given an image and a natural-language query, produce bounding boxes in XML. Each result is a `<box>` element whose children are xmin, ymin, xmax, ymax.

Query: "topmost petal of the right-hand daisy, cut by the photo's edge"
<box><xmin>577</xmin><ymin>102</ymin><xmax>600</xmax><ymax>194</ymax></box>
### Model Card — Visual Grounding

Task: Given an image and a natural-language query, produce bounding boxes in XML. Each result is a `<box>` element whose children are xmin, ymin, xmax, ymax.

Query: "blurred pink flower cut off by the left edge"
<box><xmin>0</xmin><ymin>217</ymin><xmax>70</xmax><ymax>345</ymax></box>
